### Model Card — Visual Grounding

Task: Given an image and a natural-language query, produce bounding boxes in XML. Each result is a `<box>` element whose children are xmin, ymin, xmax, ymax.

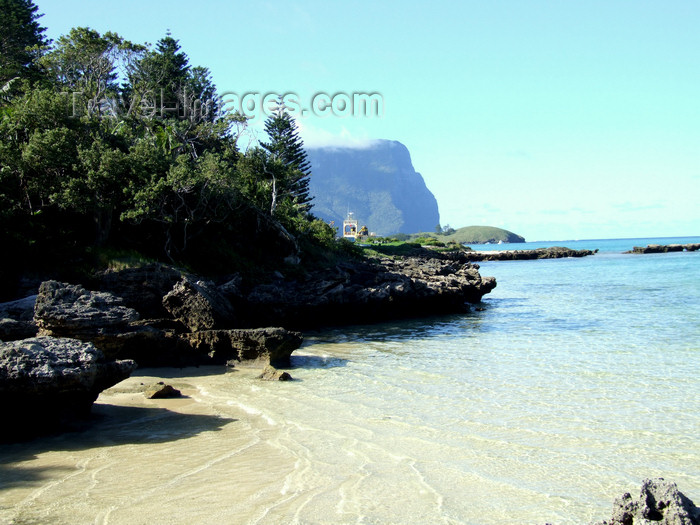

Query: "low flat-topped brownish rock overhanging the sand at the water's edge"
<box><xmin>180</xmin><ymin>328</ymin><xmax>303</xmax><ymax>367</ymax></box>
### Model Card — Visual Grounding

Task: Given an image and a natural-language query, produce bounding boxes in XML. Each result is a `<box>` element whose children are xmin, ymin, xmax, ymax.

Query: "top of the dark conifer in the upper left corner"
<box><xmin>0</xmin><ymin>0</ymin><xmax>48</xmax><ymax>95</ymax></box>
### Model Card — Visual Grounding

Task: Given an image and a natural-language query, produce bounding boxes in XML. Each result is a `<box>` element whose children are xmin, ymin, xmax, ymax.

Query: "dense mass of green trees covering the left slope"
<box><xmin>0</xmin><ymin>6</ymin><xmax>344</xmax><ymax>294</ymax></box>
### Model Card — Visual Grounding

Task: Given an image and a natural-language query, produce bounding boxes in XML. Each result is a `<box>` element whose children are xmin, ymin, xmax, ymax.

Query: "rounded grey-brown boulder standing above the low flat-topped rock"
<box><xmin>163</xmin><ymin>277</ymin><xmax>235</xmax><ymax>332</ymax></box>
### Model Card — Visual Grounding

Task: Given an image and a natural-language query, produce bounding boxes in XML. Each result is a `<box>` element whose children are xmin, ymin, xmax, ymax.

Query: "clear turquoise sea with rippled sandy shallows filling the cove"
<box><xmin>0</xmin><ymin>237</ymin><xmax>700</xmax><ymax>525</ymax></box>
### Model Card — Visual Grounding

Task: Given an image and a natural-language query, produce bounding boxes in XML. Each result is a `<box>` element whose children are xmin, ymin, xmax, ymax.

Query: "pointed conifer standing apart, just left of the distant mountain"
<box><xmin>262</xmin><ymin>100</ymin><xmax>313</xmax><ymax>213</ymax></box>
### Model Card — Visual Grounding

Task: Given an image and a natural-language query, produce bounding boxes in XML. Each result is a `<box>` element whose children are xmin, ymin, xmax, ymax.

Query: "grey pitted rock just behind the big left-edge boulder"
<box><xmin>34</xmin><ymin>281</ymin><xmax>139</xmax><ymax>340</ymax></box>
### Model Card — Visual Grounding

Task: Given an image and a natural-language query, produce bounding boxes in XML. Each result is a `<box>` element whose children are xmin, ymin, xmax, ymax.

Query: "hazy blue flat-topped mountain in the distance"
<box><xmin>306</xmin><ymin>140</ymin><xmax>440</xmax><ymax>235</ymax></box>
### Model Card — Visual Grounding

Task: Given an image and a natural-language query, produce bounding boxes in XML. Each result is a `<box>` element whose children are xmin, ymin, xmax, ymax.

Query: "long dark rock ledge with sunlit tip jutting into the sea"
<box><xmin>245</xmin><ymin>250</ymin><xmax>496</xmax><ymax>329</ymax></box>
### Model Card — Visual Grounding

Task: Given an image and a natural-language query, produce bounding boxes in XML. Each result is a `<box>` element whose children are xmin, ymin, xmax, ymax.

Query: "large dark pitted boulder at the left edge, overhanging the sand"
<box><xmin>0</xmin><ymin>337</ymin><xmax>136</xmax><ymax>439</ymax></box>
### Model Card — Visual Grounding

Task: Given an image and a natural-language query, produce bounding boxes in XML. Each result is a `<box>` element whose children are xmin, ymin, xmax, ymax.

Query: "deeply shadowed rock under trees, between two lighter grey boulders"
<box><xmin>95</xmin><ymin>263</ymin><xmax>182</xmax><ymax>319</ymax></box>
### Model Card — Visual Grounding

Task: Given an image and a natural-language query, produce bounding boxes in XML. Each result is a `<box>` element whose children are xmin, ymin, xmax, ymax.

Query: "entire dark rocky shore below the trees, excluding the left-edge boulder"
<box><xmin>19</xmin><ymin>247</ymin><xmax>496</xmax><ymax>368</ymax></box>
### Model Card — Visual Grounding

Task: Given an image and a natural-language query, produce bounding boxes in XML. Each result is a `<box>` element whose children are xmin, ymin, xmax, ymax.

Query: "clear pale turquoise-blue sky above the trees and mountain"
<box><xmin>35</xmin><ymin>0</ymin><xmax>700</xmax><ymax>241</ymax></box>
